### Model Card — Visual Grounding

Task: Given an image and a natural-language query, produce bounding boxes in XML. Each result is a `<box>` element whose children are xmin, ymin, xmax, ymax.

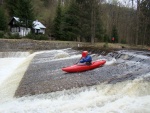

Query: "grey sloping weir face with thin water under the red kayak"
<box><xmin>10</xmin><ymin>49</ymin><xmax>150</xmax><ymax>97</ymax></box>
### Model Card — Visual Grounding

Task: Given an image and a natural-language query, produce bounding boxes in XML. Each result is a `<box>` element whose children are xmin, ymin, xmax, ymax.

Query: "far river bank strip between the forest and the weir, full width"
<box><xmin>0</xmin><ymin>39</ymin><xmax>149</xmax><ymax>52</ymax></box>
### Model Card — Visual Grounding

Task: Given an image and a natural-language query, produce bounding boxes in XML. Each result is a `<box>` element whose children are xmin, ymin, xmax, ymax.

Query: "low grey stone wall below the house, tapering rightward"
<box><xmin>0</xmin><ymin>39</ymin><xmax>89</xmax><ymax>52</ymax></box>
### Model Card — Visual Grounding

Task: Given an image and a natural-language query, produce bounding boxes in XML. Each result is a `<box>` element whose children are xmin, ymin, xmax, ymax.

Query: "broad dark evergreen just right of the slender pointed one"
<box><xmin>63</xmin><ymin>0</ymin><xmax>80</xmax><ymax>41</ymax></box>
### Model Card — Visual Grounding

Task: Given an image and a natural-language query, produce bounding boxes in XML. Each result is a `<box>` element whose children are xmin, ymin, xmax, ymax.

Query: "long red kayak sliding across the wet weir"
<box><xmin>62</xmin><ymin>60</ymin><xmax>106</xmax><ymax>73</ymax></box>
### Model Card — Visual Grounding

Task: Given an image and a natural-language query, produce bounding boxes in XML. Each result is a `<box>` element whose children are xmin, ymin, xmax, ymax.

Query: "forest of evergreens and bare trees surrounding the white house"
<box><xmin>0</xmin><ymin>0</ymin><xmax>150</xmax><ymax>46</ymax></box>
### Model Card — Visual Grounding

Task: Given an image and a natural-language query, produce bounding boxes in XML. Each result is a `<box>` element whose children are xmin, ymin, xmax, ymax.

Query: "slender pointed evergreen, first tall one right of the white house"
<box><xmin>53</xmin><ymin>1</ymin><xmax>62</xmax><ymax>40</ymax></box>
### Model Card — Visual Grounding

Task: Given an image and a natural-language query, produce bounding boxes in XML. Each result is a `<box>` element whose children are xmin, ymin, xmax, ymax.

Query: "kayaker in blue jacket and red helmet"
<box><xmin>79</xmin><ymin>51</ymin><xmax>92</xmax><ymax>65</ymax></box>
